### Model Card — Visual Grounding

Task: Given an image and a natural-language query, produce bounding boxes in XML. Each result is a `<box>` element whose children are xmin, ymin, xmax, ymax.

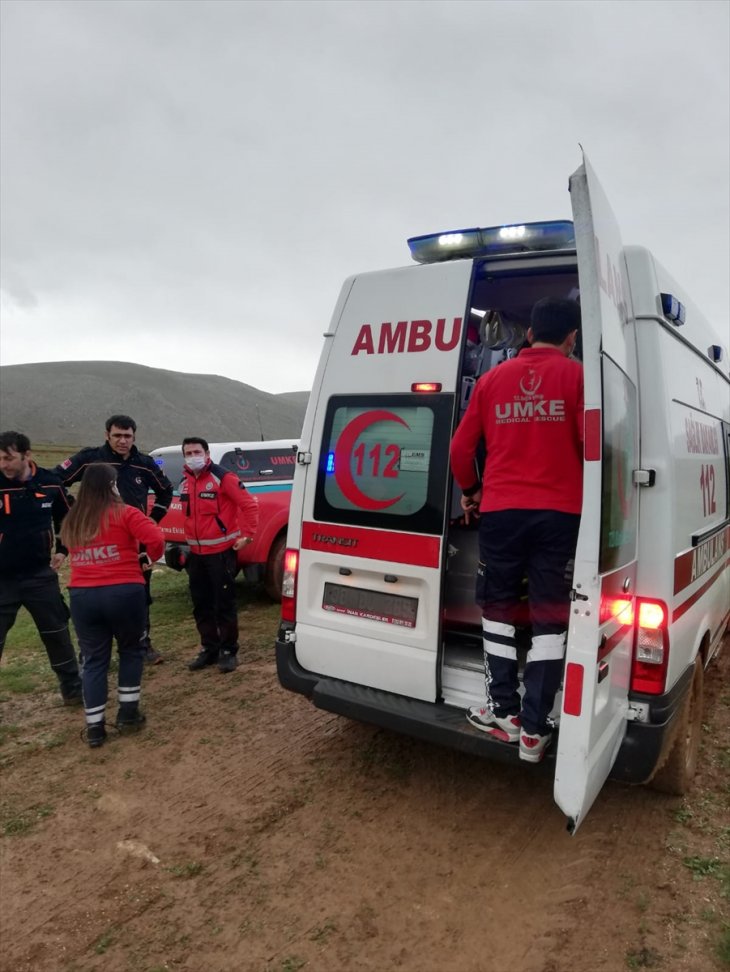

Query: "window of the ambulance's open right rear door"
<box><xmin>599</xmin><ymin>356</ymin><xmax>639</xmax><ymax>573</ymax></box>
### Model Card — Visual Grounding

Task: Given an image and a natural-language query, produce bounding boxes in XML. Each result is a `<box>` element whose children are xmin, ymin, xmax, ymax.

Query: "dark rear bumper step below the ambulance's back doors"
<box><xmin>276</xmin><ymin>637</ymin><xmax>556</xmax><ymax>776</ymax></box>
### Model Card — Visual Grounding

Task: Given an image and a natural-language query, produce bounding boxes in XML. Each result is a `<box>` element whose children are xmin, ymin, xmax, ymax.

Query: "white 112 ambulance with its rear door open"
<box><xmin>276</xmin><ymin>159</ymin><xmax>730</xmax><ymax>833</ymax></box>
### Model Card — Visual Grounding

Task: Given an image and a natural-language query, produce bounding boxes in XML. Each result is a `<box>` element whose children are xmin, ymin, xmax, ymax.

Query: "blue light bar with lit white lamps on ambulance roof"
<box><xmin>408</xmin><ymin>220</ymin><xmax>575</xmax><ymax>263</ymax></box>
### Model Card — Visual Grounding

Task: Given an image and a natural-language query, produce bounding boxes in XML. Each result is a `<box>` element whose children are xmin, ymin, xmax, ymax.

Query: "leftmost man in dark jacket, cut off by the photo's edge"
<box><xmin>0</xmin><ymin>432</ymin><xmax>81</xmax><ymax>705</ymax></box>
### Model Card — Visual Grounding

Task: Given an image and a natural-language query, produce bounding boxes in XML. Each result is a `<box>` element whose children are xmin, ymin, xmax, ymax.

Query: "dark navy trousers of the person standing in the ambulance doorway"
<box><xmin>477</xmin><ymin>510</ymin><xmax>580</xmax><ymax>735</ymax></box>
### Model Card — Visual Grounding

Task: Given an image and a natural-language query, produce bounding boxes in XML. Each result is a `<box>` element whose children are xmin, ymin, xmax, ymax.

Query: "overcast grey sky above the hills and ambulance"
<box><xmin>0</xmin><ymin>0</ymin><xmax>730</xmax><ymax>392</ymax></box>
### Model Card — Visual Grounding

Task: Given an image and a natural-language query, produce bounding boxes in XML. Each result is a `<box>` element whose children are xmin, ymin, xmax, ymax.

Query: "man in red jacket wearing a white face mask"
<box><xmin>180</xmin><ymin>436</ymin><xmax>259</xmax><ymax>672</ymax></box>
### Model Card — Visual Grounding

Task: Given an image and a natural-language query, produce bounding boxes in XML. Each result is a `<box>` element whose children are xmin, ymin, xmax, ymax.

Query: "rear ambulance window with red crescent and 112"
<box><xmin>314</xmin><ymin>395</ymin><xmax>454</xmax><ymax>534</ymax></box>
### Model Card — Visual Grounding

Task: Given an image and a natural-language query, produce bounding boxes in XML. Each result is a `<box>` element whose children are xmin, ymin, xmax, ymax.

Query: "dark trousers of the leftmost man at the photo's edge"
<box><xmin>0</xmin><ymin>566</ymin><xmax>81</xmax><ymax>696</ymax></box>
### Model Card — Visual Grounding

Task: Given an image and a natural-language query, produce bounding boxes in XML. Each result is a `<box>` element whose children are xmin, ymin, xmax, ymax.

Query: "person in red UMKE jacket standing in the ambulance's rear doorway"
<box><xmin>451</xmin><ymin>297</ymin><xmax>584</xmax><ymax>763</ymax></box>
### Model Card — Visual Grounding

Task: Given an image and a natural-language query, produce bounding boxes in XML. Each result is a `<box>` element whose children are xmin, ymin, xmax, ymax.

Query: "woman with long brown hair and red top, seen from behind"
<box><xmin>61</xmin><ymin>463</ymin><xmax>165</xmax><ymax>748</ymax></box>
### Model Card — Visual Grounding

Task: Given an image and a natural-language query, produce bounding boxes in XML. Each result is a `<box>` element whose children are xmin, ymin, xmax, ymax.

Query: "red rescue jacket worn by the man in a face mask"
<box><xmin>180</xmin><ymin>462</ymin><xmax>259</xmax><ymax>556</ymax></box>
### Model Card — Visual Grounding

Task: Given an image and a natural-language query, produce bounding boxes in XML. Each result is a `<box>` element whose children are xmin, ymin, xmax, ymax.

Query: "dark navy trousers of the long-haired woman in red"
<box><xmin>70</xmin><ymin>584</ymin><xmax>147</xmax><ymax>724</ymax></box>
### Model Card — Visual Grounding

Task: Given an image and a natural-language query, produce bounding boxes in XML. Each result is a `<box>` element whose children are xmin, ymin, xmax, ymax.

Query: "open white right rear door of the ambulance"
<box><xmin>554</xmin><ymin>156</ymin><xmax>638</xmax><ymax>833</ymax></box>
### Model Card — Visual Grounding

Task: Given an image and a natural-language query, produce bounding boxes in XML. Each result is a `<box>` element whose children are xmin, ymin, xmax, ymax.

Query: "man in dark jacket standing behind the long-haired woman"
<box><xmin>54</xmin><ymin>415</ymin><xmax>173</xmax><ymax>665</ymax></box>
